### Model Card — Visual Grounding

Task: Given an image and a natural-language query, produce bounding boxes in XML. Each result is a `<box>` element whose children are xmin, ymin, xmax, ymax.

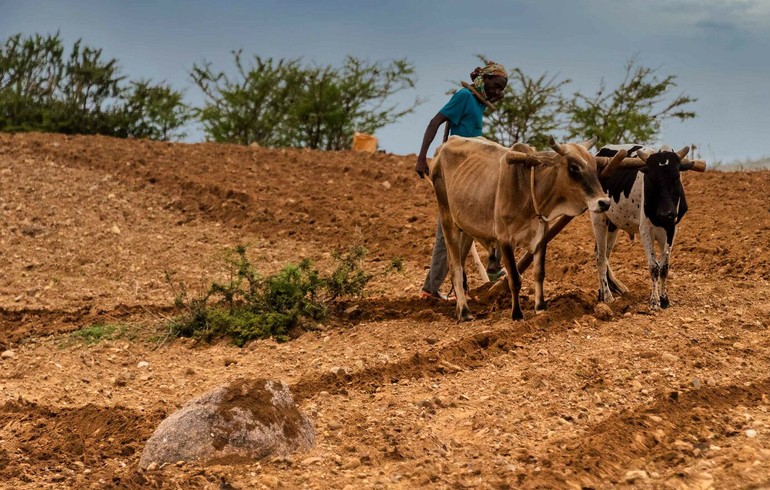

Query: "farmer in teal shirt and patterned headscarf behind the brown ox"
<box><xmin>415</xmin><ymin>61</ymin><xmax>508</xmax><ymax>299</ymax></box>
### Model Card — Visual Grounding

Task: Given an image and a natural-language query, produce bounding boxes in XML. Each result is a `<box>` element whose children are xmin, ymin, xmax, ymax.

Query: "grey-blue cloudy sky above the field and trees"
<box><xmin>0</xmin><ymin>0</ymin><xmax>770</xmax><ymax>162</ymax></box>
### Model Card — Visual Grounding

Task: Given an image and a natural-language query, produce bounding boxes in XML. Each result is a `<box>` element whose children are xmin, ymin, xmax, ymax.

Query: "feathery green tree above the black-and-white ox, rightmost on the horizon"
<box><xmin>565</xmin><ymin>57</ymin><xmax>697</xmax><ymax>146</ymax></box>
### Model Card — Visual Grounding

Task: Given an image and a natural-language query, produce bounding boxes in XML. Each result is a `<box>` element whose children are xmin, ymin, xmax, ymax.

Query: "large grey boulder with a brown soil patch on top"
<box><xmin>139</xmin><ymin>379</ymin><xmax>315</xmax><ymax>469</ymax></box>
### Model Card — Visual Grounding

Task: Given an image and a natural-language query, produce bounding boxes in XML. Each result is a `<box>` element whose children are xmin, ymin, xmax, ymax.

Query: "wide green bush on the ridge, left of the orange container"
<box><xmin>190</xmin><ymin>50</ymin><xmax>419</xmax><ymax>150</ymax></box>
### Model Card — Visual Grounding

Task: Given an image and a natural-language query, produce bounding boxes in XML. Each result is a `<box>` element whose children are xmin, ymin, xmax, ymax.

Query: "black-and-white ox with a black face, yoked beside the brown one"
<box><xmin>591</xmin><ymin>145</ymin><xmax>692</xmax><ymax>308</ymax></box>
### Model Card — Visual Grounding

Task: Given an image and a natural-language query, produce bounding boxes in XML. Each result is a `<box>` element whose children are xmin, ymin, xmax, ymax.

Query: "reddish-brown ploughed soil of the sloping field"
<box><xmin>0</xmin><ymin>134</ymin><xmax>770</xmax><ymax>489</ymax></box>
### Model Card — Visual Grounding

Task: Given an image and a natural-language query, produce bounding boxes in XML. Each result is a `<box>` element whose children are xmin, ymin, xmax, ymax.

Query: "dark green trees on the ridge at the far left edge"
<box><xmin>0</xmin><ymin>33</ymin><xmax>189</xmax><ymax>139</ymax></box>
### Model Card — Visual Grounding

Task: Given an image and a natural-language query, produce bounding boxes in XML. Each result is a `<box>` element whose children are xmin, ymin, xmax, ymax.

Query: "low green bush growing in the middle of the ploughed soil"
<box><xmin>167</xmin><ymin>245</ymin><xmax>372</xmax><ymax>346</ymax></box>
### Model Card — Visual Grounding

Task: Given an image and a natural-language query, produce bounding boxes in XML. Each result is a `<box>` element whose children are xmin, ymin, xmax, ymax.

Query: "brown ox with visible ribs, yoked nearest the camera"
<box><xmin>430</xmin><ymin>136</ymin><xmax>622</xmax><ymax>320</ymax></box>
